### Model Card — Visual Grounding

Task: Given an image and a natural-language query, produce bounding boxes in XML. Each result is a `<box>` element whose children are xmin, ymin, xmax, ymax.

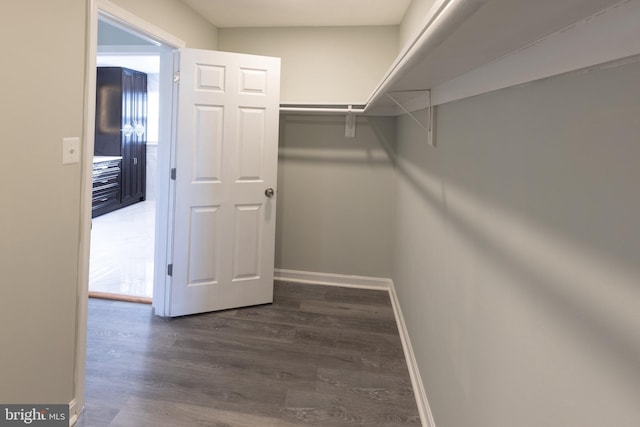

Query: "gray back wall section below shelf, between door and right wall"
<box><xmin>276</xmin><ymin>115</ymin><xmax>395</xmax><ymax>277</ymax></box>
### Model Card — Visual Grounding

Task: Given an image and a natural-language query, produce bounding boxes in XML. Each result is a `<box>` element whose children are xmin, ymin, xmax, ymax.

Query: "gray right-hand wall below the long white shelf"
<box><xmin>393</xmin><ymin>64</ymin><xmax>640</xmax><ymax>427</ymax></box>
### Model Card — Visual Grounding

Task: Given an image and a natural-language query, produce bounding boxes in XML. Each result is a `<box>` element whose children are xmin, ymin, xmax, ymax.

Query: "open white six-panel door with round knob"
<box><xmin>168</xmin><ymin>49</ymin><xmax>280</xmax><ymax>316</ymax></box>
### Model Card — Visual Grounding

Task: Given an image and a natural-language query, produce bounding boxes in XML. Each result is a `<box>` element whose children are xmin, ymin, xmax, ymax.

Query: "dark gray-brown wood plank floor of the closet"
<box><xmin>78</xmin><ymin>282</ymin><xmax>420</xmax><ymax>427</ymax></box>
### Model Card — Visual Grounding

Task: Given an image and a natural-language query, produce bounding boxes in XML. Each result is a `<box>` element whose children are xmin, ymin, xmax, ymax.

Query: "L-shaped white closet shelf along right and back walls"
<box><xmin>280</xmin><ymin>0</ymin><xmax>640</xmax><ymax>115</ymax></box>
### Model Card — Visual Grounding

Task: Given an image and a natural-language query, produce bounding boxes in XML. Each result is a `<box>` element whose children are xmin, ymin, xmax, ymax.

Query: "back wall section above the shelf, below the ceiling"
<box><xmin>218</xmin><ymin>26</ymin><xmax>398</xmax><ymax>104</ymax></box>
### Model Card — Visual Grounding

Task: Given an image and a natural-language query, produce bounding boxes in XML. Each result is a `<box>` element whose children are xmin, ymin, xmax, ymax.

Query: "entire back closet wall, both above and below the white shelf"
<box><xmin>219</xmin><ymin>26</ymin><xmax>398</xmax><ymax>277</ymax></box>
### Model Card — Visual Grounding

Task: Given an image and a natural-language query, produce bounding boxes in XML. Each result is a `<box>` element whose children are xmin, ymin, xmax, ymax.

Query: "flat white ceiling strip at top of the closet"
<box><xmin>182</xmin><ymin>0</ymin><xmax>411</xmax><ymax>28</ymax></box>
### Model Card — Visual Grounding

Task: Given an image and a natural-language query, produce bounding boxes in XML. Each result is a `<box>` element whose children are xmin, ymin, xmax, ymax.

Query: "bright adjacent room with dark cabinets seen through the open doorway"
<box><xmin>89</xmin><ymin>18</ymin><xmax>161</xmax><ymax>303</ymax></box>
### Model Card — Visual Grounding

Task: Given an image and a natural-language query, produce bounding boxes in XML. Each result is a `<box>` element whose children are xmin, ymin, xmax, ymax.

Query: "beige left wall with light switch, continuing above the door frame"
<box><xmin>0</xmin><ymin>0</ymin><xmax>216</xmax><ymax>403</ymax></box>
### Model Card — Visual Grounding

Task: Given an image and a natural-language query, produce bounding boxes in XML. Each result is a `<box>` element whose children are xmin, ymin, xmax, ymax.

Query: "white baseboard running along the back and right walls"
<box><xmin>274</xmin><ymin>269</ymin><xmax>435</xmax><ymax>427</ymax></box>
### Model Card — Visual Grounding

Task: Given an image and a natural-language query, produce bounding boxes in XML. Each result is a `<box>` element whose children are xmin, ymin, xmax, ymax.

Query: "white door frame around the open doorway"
<box><xmin>76</xmin><ymin>0</ymin><xmax>186</xmax><ymax>425</ymax></box>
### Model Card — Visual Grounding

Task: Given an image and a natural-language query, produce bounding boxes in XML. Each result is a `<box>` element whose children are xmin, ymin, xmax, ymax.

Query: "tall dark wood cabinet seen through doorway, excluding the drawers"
<box><xmin>94</xmin><ymin>67</ymin><xmax>147</xmax><ymax>211</ymax></box>
